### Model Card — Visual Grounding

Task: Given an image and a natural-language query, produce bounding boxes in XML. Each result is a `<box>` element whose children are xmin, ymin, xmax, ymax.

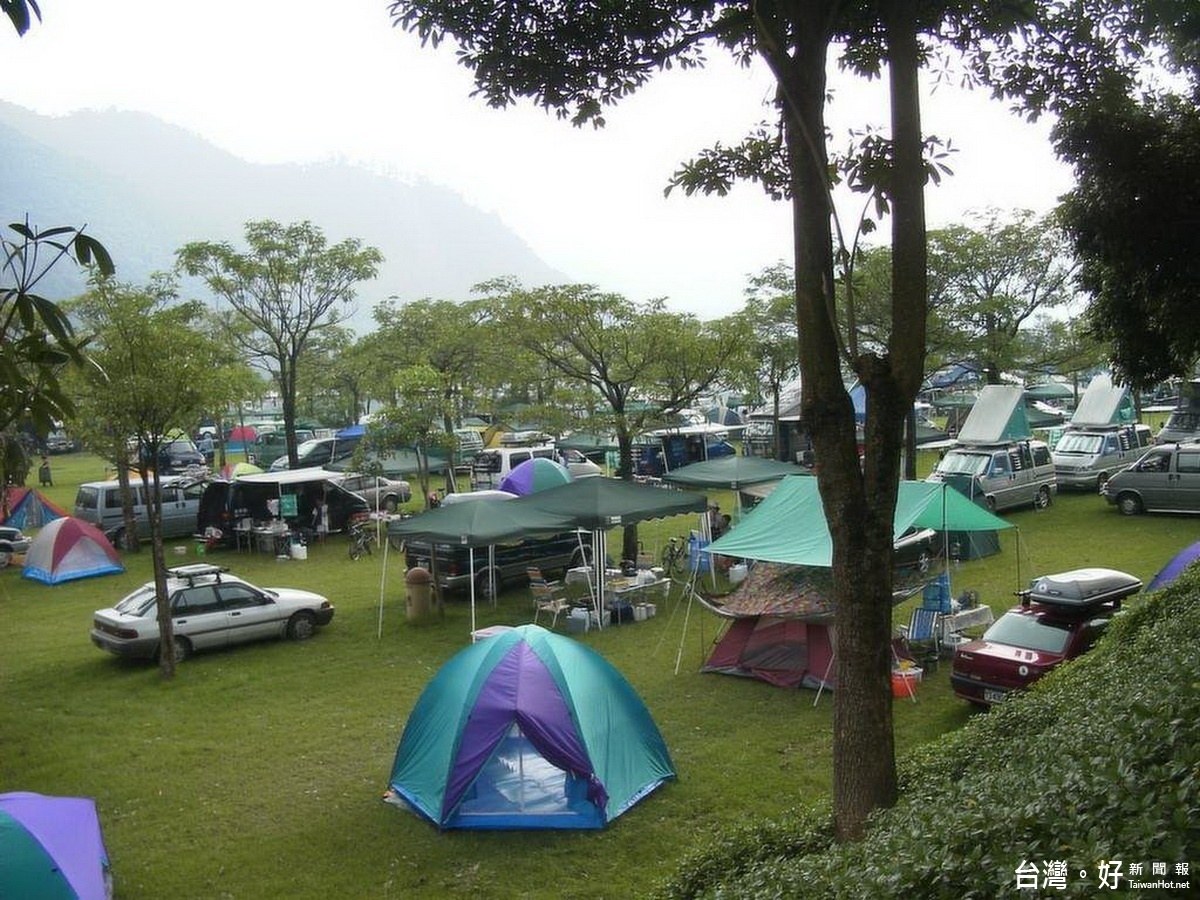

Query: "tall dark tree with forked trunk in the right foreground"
<box><xmin>391</xmin><ymin>0</ymin><xmax>943</xmax><ymax>836</ymax></box>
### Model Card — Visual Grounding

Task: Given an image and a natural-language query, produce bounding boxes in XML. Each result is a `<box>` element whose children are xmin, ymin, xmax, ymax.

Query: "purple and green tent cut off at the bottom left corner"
<box><xmin>0</xmin><ymin>791</ymin><xmax>113</xmax><ymax>900</ymax></box>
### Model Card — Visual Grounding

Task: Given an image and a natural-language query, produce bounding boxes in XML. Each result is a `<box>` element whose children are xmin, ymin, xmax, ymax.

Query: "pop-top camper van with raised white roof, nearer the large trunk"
<box><xmin>926</xmin><ymin>384</ymin><xmax>1058</xmax><ymax>511</ymax></box>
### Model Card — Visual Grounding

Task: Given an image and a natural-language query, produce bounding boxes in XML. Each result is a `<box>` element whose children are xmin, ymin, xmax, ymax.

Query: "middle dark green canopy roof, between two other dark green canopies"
<box><xmin>513</xmin><ymin>475</ymin><xmax>707</xmax><ymax>532</ymax></box>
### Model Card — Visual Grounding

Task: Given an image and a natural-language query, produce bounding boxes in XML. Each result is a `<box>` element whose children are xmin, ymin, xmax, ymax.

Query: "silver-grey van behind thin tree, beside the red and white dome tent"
<box><xmin>72</xmin><ymin>475</ymin><xmax>205</xmax><ymax>546</ymax></box>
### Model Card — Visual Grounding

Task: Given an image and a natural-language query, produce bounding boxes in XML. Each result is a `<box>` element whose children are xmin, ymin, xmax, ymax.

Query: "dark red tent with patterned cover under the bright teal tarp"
<box><xmin>701</xmin><ymin>563</ymin><xmax>834</xmax><ymax>688</ymax></box>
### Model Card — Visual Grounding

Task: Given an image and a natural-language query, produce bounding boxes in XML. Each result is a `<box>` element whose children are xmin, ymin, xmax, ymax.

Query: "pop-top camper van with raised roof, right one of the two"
<box><xmin>1054</xmin><ymin>376</ymin><xmax>1151</xmax><ymax>491</ymax></box>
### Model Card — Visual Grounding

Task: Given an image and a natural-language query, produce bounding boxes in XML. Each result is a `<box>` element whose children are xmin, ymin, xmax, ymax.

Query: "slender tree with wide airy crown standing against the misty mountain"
<box><xmin>178</xmin><ymin>221</ymin><xmax>383</xmax><ymax>466</ymax></box>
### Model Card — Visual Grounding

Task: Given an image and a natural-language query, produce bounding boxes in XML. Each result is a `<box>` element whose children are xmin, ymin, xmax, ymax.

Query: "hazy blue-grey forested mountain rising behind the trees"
<box><xmin>0</xmin><ymin>102</ymin><xmax>568</xmax><ymax>328</ymax></box>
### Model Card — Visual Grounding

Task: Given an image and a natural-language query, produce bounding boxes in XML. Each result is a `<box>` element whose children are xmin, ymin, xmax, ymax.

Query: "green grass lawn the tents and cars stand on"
<box><xmin>0</xmin><ymin>454</ymin><xmax>1200</xmax><ymax>900</ymax></box>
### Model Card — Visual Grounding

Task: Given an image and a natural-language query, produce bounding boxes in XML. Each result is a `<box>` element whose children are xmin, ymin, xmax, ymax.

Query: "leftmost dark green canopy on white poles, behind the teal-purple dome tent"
<box><xmin>379</xmin><ymin>494</ymin><xmax>575</xmax><ymax>635</ymax></box>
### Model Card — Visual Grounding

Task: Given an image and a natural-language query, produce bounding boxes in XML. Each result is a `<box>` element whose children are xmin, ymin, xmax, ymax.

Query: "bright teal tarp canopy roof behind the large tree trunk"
<box><xmin>707</xmin><ymin>476</ymin><xmax>1012</xmax><ymax>566</ymax></box>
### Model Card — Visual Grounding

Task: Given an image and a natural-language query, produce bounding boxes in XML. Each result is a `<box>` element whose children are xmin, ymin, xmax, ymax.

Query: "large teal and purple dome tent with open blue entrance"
<box><xmin>390</xmin><ymin>628</ymin><xmax>676</xmax><ymax>829</ymax></box>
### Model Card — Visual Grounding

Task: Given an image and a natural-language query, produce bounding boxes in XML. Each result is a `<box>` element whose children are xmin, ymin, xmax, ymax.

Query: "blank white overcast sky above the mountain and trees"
<box><xmin>0</xmin><ymin>0</ymin><xmax>1070</xmax><ymax>318</ymax></box>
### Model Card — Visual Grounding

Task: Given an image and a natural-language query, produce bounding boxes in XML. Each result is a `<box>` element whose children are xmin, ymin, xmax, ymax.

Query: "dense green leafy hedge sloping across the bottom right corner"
<box><xmin>659</xmin><ymin>574</ymin><xmax>1200</xmax><ymax>900</ymax></box>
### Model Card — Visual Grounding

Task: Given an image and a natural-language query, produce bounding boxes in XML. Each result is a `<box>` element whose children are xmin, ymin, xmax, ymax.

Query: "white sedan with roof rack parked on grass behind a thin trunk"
<box><xmin>91</xmin><ymin>564</ymin><xmax>334</xmax><ymax>660</ymax></box>
